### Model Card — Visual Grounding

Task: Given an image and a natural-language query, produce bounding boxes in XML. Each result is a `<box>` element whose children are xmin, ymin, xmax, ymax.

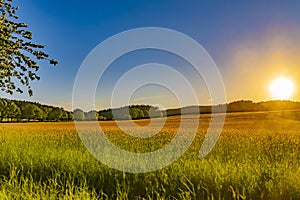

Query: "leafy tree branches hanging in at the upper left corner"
<box><xmin>0</xmin><ymin>0</ymin><xmax>57</xmax><ymax>96</ymax></box>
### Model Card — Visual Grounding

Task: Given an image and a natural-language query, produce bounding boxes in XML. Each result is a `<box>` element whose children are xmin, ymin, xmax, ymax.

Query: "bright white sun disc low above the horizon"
<box><xmin>270</xmin><ymin>77</ymin><xmax>295</xmax><ymax>100</ymax></box>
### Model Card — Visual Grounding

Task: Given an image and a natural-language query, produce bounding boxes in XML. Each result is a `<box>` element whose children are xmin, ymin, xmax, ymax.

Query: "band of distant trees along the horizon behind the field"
<box><xmin>0</xmin><ymin>98</ymin><xmax>300</xmax><ymax>122</ymax></box>
